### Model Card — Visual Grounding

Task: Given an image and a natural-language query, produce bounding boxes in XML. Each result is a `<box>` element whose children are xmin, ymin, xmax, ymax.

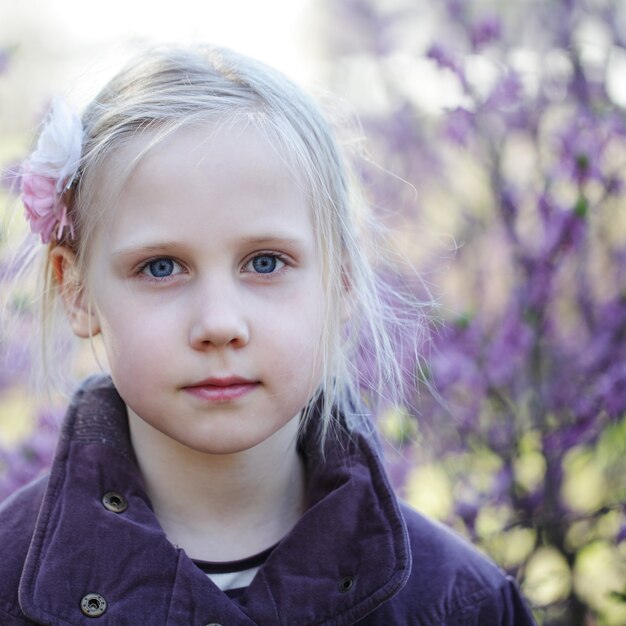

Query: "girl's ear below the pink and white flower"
<box><xmin>50</xmin><ymin>246</ymin><xmax>100</xmax><ymax>339</ymax></box>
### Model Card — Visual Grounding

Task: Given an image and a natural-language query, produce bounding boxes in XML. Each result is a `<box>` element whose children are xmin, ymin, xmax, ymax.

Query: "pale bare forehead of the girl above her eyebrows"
<box><xmin>91</xmin><ymin>123</ymin><xmax>311</xmax><ymax>247</ymax></box>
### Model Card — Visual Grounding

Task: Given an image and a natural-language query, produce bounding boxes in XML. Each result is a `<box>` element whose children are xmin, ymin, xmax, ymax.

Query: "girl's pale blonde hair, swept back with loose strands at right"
<box><xmin>34</xmin><ymin>46</ymin><xmax>420</xmax><ymax>441</ymax></box>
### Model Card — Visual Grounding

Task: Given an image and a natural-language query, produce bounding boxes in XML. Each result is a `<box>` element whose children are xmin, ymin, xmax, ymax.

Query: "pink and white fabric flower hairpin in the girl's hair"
<box><xmin>22</xmin><ymin>98</ymin><xmax>83</xmax><ymax>243</ymax></box>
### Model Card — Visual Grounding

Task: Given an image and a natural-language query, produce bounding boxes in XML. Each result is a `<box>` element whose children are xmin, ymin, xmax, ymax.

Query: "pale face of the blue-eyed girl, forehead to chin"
<box><xmin>80</xmin><ymin>126</ymin><xmax>325</xmax><ymax>454</ymax></box>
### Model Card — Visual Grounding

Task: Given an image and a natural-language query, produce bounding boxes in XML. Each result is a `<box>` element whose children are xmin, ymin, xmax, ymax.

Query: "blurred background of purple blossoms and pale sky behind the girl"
<box><xmin>0</xmin><ymin>0</ymin><xmax>626</xmax><ymax>626</ymax></box>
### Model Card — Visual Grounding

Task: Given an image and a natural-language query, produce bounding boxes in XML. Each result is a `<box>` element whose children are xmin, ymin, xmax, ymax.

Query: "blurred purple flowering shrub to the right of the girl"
<box><xmin>326</xmin><ymin>0</ymin><xmax>626</xmax><ymax>626</ymax></box>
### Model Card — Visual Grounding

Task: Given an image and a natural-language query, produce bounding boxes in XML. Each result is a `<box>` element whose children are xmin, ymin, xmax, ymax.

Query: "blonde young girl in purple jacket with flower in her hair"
<box><xmin>0</xmin><ymin>48</ymin><xmax>533</xmax><ymax>626</ymax></box>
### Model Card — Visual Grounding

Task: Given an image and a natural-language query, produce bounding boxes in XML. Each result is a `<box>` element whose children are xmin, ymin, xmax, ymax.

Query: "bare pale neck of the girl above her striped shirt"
<box><xmin>128</xmin><ymin>409</ymin><xmax>305</xmax><ymax>561</ymax></box>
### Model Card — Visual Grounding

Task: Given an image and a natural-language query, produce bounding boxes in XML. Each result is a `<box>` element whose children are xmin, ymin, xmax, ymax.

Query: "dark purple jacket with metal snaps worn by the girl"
<box><xmin>0</xmin><ymin>377</ymin><xmax>534</xmax><ymax>626</ymax></box>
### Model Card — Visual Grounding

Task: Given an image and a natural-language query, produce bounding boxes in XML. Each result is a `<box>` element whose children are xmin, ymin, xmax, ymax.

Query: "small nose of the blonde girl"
<box><xmin>189</xmin><ymin>285</ymin><xmax>250</xmax><ymax>350</ymax></box>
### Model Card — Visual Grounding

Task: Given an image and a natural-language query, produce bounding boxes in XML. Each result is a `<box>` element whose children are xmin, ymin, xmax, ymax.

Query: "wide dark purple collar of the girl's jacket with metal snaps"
<box><xmin>20</xmin><ymin>377</ymin><xmax>411</xmax><ymax>626</ymax></box>
